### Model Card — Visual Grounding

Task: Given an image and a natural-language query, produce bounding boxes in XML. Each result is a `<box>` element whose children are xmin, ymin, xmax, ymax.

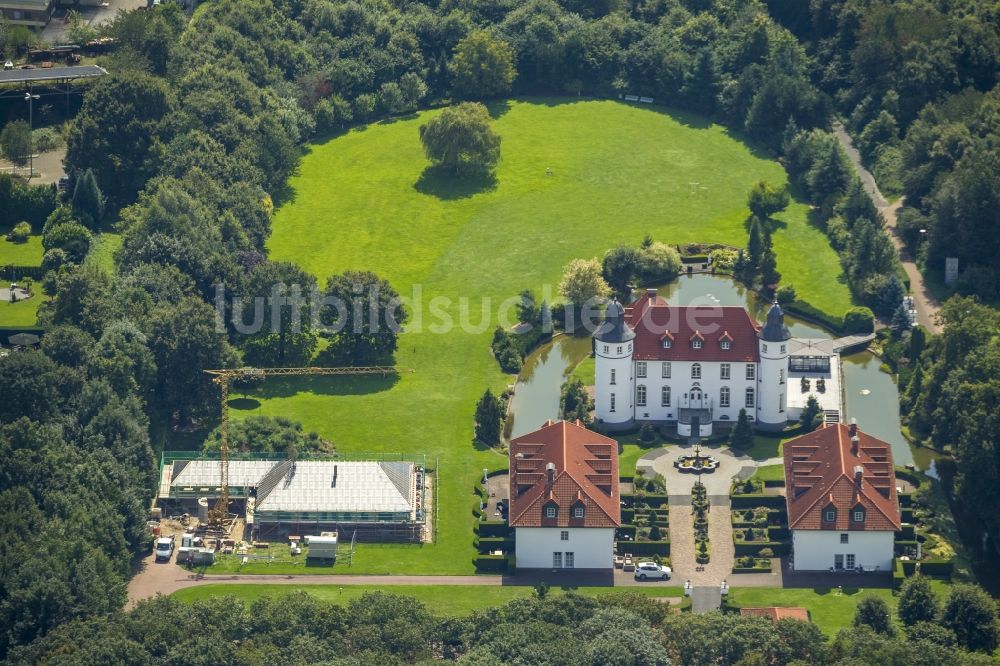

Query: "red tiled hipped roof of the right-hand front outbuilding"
<box><xmin>784</xmin><ymin>423</ymin><xmax>901</xmax><ymax>531</ymax></box>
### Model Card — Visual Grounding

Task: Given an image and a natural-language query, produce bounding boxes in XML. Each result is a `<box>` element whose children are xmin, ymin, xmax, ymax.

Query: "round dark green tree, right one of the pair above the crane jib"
<box><xmin>320</xmin><ymin>271</ymin><xmax>408</xmax><ymax>366</ymax></box>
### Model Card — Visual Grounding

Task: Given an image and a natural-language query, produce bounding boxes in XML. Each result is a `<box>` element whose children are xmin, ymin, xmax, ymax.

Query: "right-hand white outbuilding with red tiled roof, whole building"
<box><xmin>784</xmin><ymin>423</ymin><xmax>901</xmax><ymax>571</ymax></box>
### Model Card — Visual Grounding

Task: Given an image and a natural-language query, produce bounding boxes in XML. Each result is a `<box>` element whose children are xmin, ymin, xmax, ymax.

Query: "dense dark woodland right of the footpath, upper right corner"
<box><xmin>768</xmin><ymin>0</ymin><xmax>1000</xmax><ymax>299</ymax></box>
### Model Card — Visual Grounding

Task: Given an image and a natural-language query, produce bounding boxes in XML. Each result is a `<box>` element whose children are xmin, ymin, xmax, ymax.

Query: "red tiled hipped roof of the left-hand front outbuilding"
<box><xmin>509</xmin><ymin>421</ymin><xmax>621</xmax><ymax>527</ymax></box>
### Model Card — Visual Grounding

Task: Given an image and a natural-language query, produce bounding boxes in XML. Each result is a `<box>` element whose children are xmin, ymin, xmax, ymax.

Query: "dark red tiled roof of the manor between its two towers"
<box><xmin>625</xmin><ymin>292</ymin><xmax>760</xmax><ymax>363</ymax></box>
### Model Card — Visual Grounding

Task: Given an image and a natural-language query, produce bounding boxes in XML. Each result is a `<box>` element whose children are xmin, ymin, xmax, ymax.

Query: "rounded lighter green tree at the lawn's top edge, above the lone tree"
<box><xmin>451</xmin><ymin>30</ymin><xmax>517</xmax><ymax>99</ymax></box>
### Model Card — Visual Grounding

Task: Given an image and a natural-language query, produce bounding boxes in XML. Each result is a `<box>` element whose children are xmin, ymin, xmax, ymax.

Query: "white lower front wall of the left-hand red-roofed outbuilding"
<box><xmin>514</xmin><ymin>527</ymin><xmax>615</xmax><ymax>569</ymax></box>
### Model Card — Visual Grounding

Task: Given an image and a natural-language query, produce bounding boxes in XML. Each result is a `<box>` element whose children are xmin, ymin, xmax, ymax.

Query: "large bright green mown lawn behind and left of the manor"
<box><xmin>252</xmin><ymin>100</ymin><xmax>850</xmax><ymax>573</ymax></box>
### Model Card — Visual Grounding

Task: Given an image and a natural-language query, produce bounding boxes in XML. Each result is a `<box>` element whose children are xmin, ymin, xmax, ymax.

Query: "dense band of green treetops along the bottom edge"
<box><xmin>12</xmin><ymin>592</ymin><xmax>994</xmax><ymax>666</ymax></box>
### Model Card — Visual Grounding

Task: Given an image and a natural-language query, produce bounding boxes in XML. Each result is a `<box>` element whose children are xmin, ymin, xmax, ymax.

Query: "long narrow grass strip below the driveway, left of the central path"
<box><xmin>173</xmin><ymin>584</ymin><xmax>684</xmax><ymax>616</ymax></box>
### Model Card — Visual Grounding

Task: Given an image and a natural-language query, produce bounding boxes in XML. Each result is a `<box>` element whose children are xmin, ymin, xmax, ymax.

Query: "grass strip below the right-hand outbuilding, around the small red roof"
<box><xmin>729</xmin><ymin>577</ymin><xmax>948</xmax><ymax>637</ymax></box>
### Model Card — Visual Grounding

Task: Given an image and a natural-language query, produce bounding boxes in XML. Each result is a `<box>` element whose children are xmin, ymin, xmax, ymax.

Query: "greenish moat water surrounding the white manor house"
<box><xmin>508</xmin><ymin>274</ymin><xmax>934</xmax><ymax>472</ymax></box>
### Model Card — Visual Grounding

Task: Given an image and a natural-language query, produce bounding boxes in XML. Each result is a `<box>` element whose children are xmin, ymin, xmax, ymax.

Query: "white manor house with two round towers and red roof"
<box><xmin>594</xmin><ymin>289</ymin><xmax>842</xmax><ymax>437</ymax></box>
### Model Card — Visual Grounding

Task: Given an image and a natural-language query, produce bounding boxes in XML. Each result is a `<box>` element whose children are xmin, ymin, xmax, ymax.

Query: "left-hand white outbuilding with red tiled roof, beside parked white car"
<box><xmin>508</xmin><ymin>421</ymin><xmax>621</xmax><ymax>570</ymax></box>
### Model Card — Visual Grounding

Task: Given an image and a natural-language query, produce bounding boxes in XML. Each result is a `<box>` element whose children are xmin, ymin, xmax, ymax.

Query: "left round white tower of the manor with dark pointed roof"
<box><xmin>594</xmin><ymin>300</ymin><xmax>635</xmax><ymax>426</ymax></box>
